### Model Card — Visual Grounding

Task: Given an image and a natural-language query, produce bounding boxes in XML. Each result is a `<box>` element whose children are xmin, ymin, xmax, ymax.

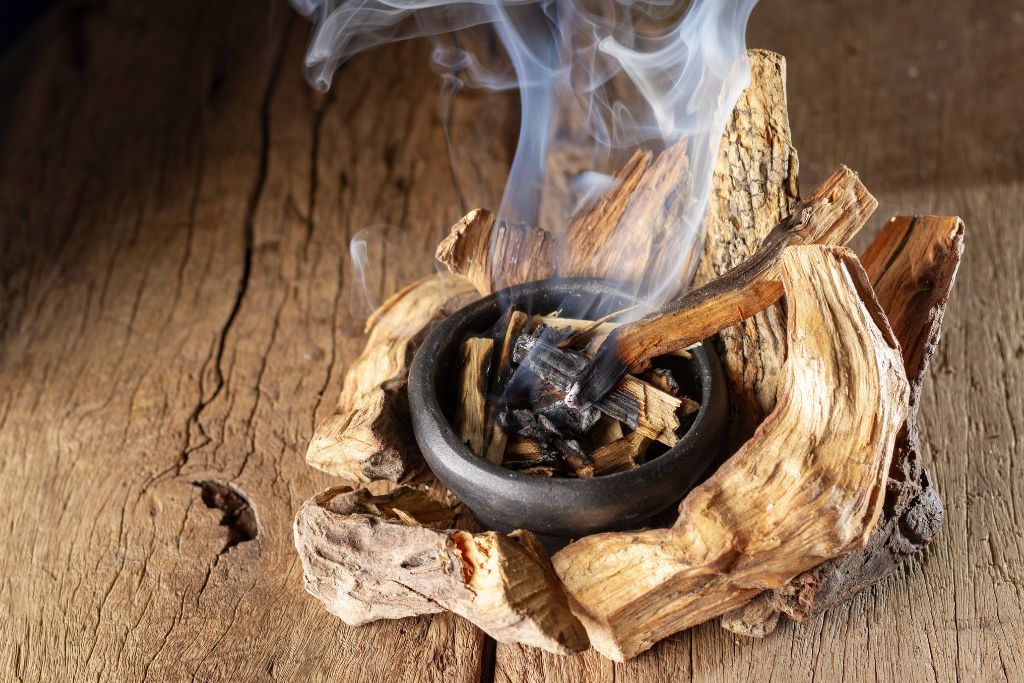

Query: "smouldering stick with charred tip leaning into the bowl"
<box><xmin>568</xmin><ymin>166</ymin><xmax>878</xmax><ymax>405</ymax></box>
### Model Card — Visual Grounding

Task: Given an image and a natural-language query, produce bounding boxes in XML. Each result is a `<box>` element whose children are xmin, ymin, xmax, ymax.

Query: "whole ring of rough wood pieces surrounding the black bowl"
<box><xmin>295</xmin><ymin>51</ymin><xmax>964</xmax><ymax>660</ymax></box>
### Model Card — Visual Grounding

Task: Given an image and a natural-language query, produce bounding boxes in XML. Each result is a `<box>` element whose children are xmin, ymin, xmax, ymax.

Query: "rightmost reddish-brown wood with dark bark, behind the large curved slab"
<box><xmin>773</xmin><ymin>216</ymin><xmax>964</xmax><ymax>622</ymax></box>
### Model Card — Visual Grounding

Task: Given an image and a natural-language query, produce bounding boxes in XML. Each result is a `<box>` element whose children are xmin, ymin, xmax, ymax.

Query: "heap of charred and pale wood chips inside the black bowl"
<box><xmin>455</xmin><ymin>310</ymin><xmax>697</xmax><ymax>477</ymax></box>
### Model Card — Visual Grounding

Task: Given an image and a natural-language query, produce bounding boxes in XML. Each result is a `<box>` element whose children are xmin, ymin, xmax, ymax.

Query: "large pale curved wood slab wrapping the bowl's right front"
<box><xmin>554</xmin><ymin>247</ymin><xmax>908</xmax><ymax>660</ymax></box>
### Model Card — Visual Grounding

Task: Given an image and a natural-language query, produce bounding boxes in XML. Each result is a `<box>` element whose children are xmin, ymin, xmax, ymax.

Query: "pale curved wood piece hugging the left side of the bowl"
<box><xmin>306</xmin><ymin>275</ymin><xmax>477</xmax><ymax>481</ymax></box>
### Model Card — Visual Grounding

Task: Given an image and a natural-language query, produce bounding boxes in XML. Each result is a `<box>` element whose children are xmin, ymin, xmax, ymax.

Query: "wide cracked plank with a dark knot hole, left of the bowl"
<box><xmin>0</xmin><ymin>0</ymin><xmax>504</xmax><ymax>681</ymax></box>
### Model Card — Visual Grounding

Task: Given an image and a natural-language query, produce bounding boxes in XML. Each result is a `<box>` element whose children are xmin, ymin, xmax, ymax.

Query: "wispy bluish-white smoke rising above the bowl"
<box><xmin>292</xmin><ymin>0</ymin><xmax>757</xmax><ymax>305</ymax></box>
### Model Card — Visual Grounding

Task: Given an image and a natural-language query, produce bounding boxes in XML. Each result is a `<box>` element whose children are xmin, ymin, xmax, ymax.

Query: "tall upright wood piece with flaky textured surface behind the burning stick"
<box><xmin>693</xmin><ymin>50</ymin><xmax>799</xmax><ymax>444</ymax></box>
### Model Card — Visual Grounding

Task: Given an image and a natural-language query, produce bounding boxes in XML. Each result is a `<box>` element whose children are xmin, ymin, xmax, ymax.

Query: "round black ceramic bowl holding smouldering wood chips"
<box><xmin>409</xmin><ymin>280</ymin><xmax>726</xmax><ymax>538</ymax></box>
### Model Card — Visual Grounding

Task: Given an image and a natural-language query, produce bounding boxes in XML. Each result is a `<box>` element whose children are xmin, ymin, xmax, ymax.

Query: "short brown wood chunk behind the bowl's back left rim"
<box><xmin>434</xmin><ymin>209</ymin><xmax>554</xmax><ymax>295</ymax></box>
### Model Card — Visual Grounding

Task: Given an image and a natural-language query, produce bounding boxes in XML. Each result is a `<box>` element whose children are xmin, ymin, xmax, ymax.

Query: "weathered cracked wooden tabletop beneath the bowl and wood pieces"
<box><xmin>0</xmin><ymin>0</ymin><xmax>1024</xmax><ymax>681</ymax></box>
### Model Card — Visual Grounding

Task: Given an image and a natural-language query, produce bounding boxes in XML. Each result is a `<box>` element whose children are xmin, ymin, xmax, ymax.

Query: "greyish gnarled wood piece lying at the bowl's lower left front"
<box><xmin>295</xmin><ymin>486</ymin><xmax>587</xmax><ymax>654</ymax></box>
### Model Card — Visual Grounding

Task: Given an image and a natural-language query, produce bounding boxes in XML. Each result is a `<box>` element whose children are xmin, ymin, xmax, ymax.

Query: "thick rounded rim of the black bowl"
<box><xmin>409</xmin><ymin>278</ymin><xmax>726</xmax><ymax>497</ymax></box>
